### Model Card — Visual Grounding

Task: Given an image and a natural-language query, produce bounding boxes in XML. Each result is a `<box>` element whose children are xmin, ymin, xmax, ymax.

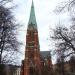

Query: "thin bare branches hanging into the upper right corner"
<box><xmin>55</xmin><ymin>0</ymin><xmax>75</xmax><ymax>13</ymax></box>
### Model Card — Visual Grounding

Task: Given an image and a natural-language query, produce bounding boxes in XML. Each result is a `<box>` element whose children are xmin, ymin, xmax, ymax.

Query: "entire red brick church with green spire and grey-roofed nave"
<box><xmin>21</xmin><ymin>1</ymin><xmax>52</xmax><ymax>75</ymax></box>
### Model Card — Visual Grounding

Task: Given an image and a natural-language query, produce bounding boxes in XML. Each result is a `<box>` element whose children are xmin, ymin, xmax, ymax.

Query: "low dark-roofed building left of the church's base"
<box><xmin>0</xmin><ymin>64</ymin><xmax>21</xmax><ymax>75</ymax></box>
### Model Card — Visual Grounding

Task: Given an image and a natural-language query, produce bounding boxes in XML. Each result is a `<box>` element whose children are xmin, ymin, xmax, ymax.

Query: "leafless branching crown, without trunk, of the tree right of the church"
<box><xmin>51</xmin><ymin>26</ymin><xmax>75</xmax><ymax>58</ymax></box>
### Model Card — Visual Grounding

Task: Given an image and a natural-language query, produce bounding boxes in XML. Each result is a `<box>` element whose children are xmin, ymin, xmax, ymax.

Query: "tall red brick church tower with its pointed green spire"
<box><xmin>23</xmin><ymin>1</ymin><xmax>41</xmax><ymax>75</ymax></box>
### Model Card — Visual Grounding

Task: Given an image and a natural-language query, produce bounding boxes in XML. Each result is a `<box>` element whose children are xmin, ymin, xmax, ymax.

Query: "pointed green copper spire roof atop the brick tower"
<box><xmin>28</xmin><ymin>1</ymin><xmax>37</xmax><ymax>29</ymax></box>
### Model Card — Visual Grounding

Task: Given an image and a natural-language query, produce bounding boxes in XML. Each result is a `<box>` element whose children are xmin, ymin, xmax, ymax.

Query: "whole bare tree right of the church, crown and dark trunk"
<box><xmin>51</xmin><ymin>25</ymin><xmax>75</xmax><ymax>75</ymax></box>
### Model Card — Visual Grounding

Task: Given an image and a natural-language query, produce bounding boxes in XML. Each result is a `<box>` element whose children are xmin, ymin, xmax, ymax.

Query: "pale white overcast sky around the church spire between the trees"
<box><xmin>7</xmin><ymin>0</ymin><xmax>69</xmax><ymax>63</ymax></box>
